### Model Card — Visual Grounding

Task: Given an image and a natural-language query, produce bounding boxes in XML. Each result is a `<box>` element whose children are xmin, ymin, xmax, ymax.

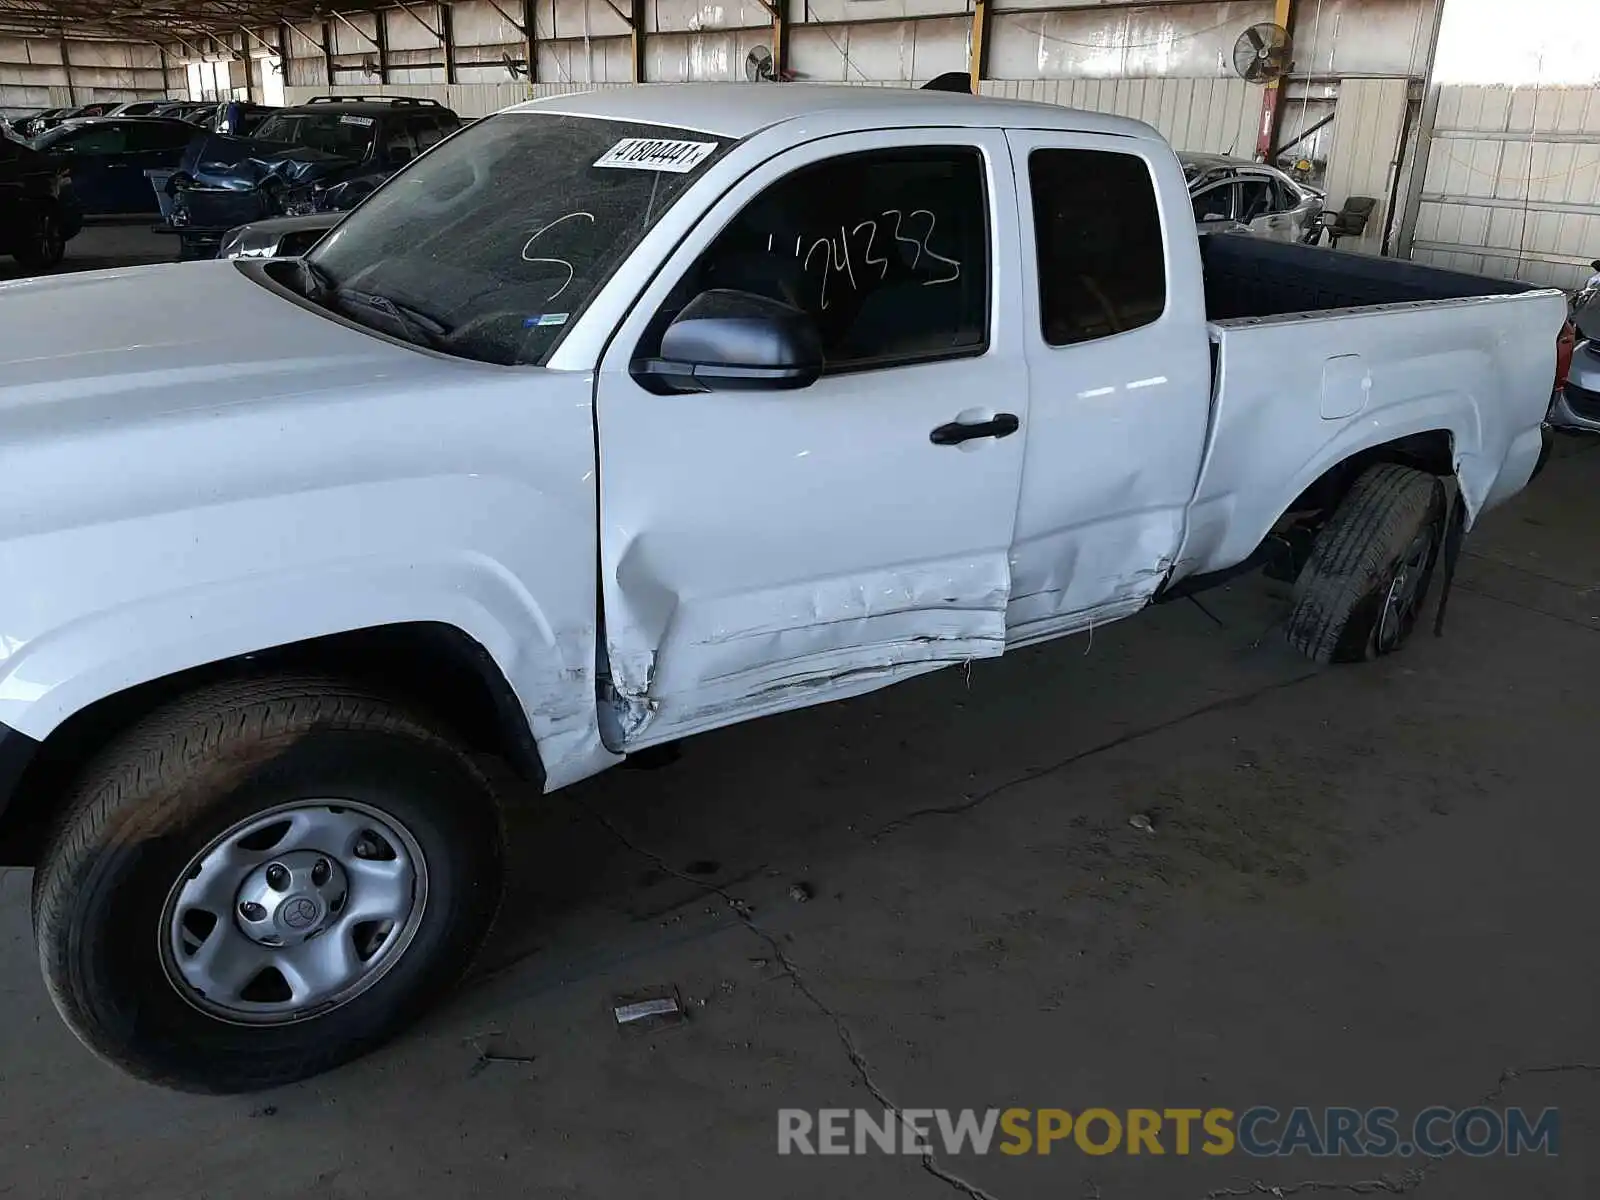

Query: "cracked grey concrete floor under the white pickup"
<box><xmin>0</xmin><ymin>240</ymin><xmax>1600</xmax><ymax>1200</ymax></box>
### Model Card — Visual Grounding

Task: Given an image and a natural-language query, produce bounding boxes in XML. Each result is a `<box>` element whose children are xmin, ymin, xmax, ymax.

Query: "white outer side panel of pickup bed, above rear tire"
<box><xmin>1174</xmin><ymin>291</ymin><xmax>1565</xmax><ymax>578</ymax></box>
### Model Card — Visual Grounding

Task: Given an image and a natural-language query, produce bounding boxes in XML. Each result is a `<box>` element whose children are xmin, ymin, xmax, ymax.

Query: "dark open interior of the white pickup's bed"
<box><xmin>1200</xmin><ymin>234</ymin><xmax>1536</xmax><ymax>322</ymax></box>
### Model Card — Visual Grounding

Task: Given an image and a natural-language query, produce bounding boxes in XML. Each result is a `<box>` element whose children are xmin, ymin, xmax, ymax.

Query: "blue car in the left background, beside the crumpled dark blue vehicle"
<box><xmin>32</xmin><ymin>117</ymin><xmax>205</xmax><ymax>216</ymax></box>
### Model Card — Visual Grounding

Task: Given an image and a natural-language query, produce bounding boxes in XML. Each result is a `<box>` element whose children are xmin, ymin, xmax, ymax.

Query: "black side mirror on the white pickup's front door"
<box><xmin>630</xmin><ymin>288</ymin><xmax>822</xmax><ymax>394</ymax></box>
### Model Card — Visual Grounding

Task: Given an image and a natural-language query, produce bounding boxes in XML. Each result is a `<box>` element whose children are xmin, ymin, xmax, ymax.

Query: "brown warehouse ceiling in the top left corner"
<box><xmin>0</xmin><ymin>0</ymin><xmax>387</xmax><ymax>42</ymax></box>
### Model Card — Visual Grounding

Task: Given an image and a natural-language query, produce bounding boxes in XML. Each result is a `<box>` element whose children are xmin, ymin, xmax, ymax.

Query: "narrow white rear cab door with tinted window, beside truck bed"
<box><xmin>1006</xmin><ymin>130</ymin><xmax>1211</xmax><ymax>645</ymax></box>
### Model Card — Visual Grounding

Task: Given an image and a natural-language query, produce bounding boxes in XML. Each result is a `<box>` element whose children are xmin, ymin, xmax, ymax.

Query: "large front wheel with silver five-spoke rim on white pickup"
<box><xmin>34</xmin><ymin>678</ymin><xmax>502</xmax><ymax>1093</ymax></box>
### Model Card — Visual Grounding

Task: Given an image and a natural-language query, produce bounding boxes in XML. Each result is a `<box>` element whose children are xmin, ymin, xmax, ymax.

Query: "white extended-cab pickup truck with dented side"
<box><xmin>0</xmin><ymin>85</ymin><xmax>1565</xmax><ymax>1091</ymax></box>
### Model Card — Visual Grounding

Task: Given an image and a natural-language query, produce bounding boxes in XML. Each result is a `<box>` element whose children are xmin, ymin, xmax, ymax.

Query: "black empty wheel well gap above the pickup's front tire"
<box><xmin>0</xmin><ymin>622</ymin><xmax>544</xmax><ymax>866</ymax></box>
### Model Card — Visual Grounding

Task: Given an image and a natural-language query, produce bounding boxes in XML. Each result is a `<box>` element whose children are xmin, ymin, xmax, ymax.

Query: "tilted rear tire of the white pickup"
<box><xmin>1288</xmin><ymin>462</ymin><xmax>1445</xmax><ymax>662</ymax></box>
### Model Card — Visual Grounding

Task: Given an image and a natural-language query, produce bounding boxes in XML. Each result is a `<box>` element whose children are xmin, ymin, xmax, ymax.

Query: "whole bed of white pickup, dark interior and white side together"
<box><xmin>1181</xmin><ymin>234</ymin><xmax>1566</xmax><ymax>588</ymax></box>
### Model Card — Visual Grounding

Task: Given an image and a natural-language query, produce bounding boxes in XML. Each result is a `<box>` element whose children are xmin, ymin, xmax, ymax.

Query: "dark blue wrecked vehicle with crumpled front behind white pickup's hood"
<box><xmin>162</xmin><ymin>96</ymin><xmax>461</xmax><ymax>259</ymax></box>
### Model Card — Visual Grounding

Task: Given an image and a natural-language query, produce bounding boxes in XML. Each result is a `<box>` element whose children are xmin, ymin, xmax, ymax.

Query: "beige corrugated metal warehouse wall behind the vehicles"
<box><xmin>28</xmin><ymin>0</ymin><xmax>1600</xmax><ymax>291</ymax></box>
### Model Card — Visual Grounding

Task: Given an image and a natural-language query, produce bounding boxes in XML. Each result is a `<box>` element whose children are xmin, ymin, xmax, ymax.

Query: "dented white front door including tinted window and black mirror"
<box><xmin>597</xmin><ymin>130</ymin><xmax>1029</xmax><ymax>749</ymax></box>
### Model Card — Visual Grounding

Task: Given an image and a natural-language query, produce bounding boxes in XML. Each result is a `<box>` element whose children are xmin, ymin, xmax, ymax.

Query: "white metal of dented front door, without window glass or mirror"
<box><xmin>597</xmin><ymin>130</ymin><xmax>1029</xmax><ymax>749</ymax></box>
